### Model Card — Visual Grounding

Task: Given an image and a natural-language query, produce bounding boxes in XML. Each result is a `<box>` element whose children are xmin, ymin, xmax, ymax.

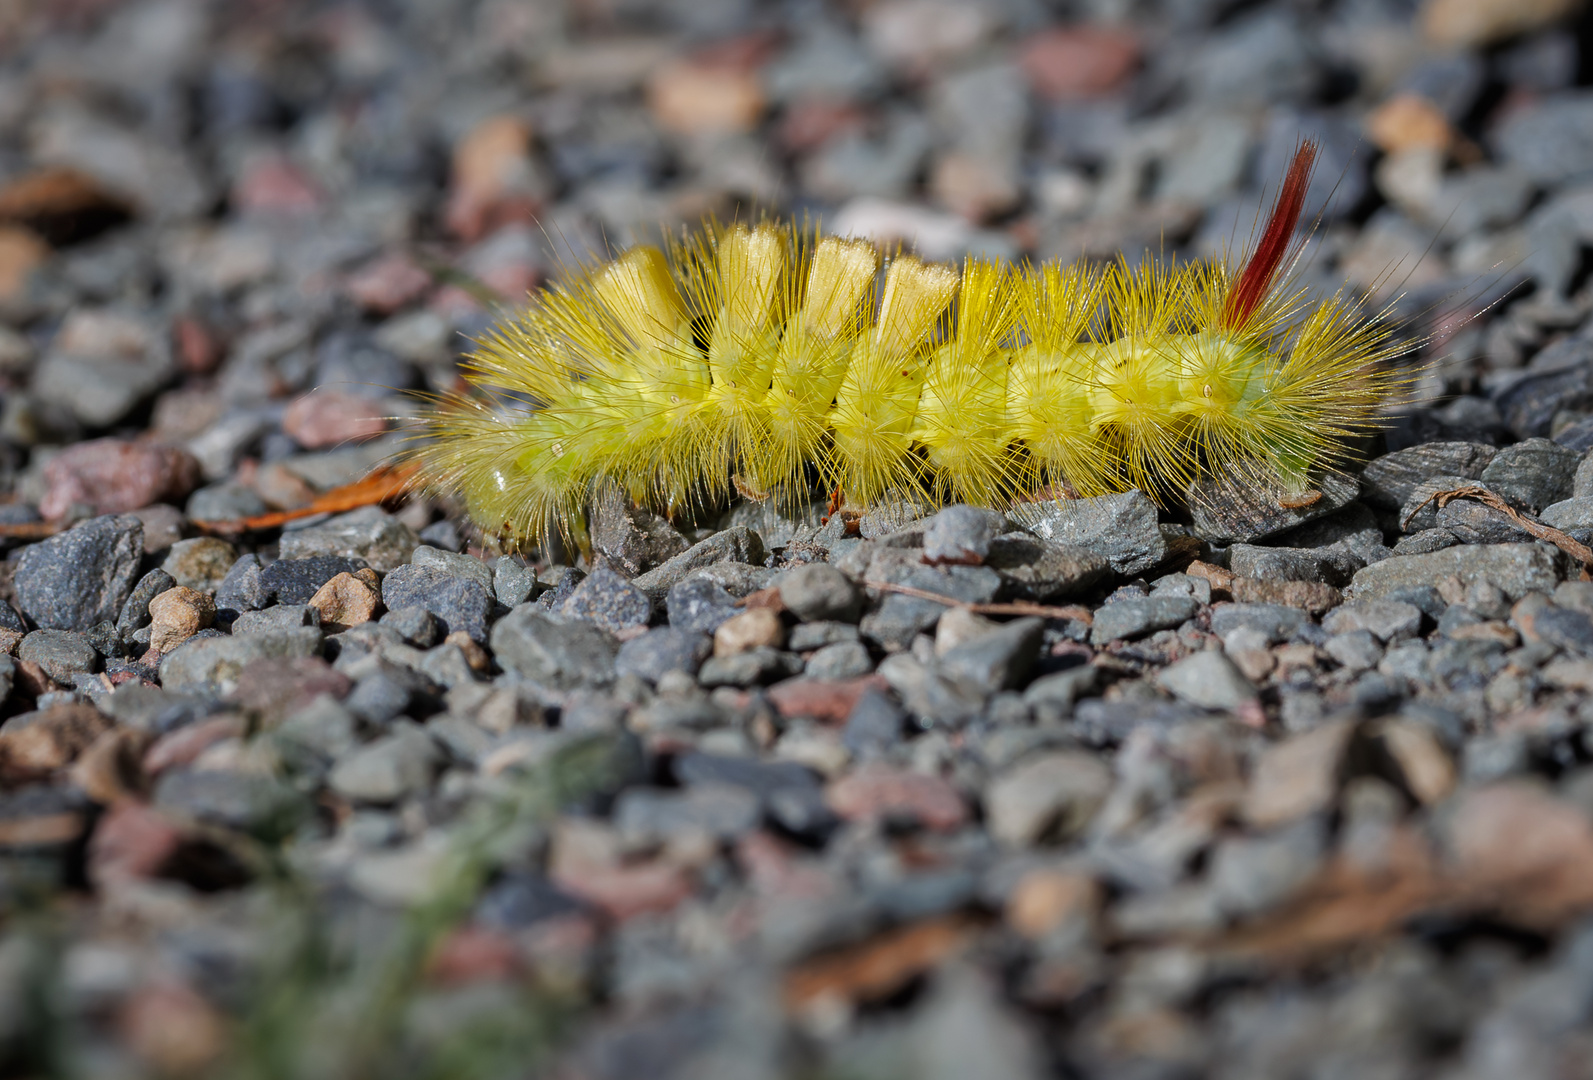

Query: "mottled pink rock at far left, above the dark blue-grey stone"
<box><xmin>38</xmin><ymin>438</ymin><xmax>199</xmax><ymax>519</ymax></box>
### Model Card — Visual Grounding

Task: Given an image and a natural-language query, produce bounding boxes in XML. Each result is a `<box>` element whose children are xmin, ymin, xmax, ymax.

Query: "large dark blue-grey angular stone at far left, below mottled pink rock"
<box><xmin>13</xmin><ymin>515</ymin><xmax>143</xmax><ymax>631</ymax></box>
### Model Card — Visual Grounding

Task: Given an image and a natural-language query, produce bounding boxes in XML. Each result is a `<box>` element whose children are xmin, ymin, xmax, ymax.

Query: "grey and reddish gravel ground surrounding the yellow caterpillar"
<box><xmin>0</xmin><ymin>0</ymin><xmax>1593</xmax><ymax>1080</ymax></box>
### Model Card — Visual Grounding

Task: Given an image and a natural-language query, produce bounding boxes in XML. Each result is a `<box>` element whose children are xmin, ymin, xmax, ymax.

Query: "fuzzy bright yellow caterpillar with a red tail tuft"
<box><xmin>414</xmin><ymin>142</ymin><xmax>1400</xmax><ymax>550</ymax></box>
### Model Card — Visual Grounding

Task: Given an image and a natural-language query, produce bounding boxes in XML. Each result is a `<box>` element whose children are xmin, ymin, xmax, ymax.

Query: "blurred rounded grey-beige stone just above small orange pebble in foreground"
<box><xmin>984</xmin><ymin>750</ymin><xmax>1112</xmax><ymax>847</ymax></box>
